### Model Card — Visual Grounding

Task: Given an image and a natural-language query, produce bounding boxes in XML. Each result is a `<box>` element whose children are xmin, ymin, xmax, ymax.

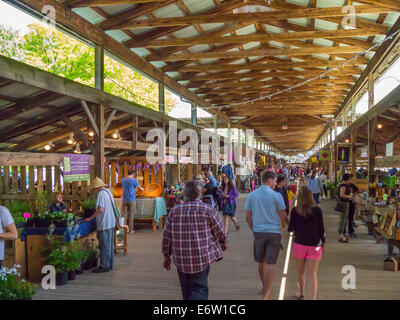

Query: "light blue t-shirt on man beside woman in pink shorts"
<box><xmin>245</xmin><ymin>185</ymin><xmax>286</xmax><ymax>234</ymax></box>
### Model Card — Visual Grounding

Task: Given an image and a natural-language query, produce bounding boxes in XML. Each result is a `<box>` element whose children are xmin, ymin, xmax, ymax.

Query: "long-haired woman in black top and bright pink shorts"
<box><xmin>288</xmin><ymin>186</ymin><xmax>325</xmax><ymax>300</ymax></box>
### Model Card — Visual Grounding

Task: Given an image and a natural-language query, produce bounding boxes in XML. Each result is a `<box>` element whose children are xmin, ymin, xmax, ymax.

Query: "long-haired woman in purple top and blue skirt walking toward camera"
<box><xmin>222</xmin><ymin>176</ymin><xmax>240</xmax><ymax>233</ymax></box>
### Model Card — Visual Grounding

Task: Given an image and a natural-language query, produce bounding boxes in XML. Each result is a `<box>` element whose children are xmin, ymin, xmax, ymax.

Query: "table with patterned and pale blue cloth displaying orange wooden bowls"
<box><xmin>114</xmin><ymin>197</ymin><xmax>167</xmax><ymax>232</ymax></box>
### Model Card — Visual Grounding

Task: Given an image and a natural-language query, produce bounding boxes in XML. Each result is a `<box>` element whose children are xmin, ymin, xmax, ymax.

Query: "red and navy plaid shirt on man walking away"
<box><xmin>162</xmin><ymin>200</ymin><xmax>226</xmax><ymax>274</ymax></box>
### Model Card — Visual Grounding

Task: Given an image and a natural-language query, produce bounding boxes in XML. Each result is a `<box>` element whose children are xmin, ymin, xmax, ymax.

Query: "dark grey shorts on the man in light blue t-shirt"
<box><xmin>253</xmin><ymin>232</ymin><xmax>281</xmax><ymax>264</ymax></box>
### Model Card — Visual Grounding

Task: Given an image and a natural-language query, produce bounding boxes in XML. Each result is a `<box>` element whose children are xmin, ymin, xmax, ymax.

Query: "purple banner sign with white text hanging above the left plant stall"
<box><xmin>63</xmin><ymin>154</ymin><xmax>90</xmax><ymax>182</ymax></box>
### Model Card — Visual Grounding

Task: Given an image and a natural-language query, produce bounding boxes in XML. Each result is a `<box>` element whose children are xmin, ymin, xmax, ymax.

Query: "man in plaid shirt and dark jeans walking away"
<box><xmin>162</xmin><ymin>181</ymin><xmax>226</xmax><ymax>300</ymax></box>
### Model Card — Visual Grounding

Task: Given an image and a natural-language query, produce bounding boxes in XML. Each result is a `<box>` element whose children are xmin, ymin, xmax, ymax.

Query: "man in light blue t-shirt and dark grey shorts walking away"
<box><xmin>245</xmin><ymin>171</ymin><xmax>289</xmax><ymax>300</ymax></box>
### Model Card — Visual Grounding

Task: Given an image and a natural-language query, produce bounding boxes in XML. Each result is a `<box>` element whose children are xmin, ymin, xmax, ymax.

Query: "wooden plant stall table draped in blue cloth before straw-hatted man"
<box><xmin>20</xmin><ymin>219</ymin><xmax>97</xmax><ymax>282</ymax></box>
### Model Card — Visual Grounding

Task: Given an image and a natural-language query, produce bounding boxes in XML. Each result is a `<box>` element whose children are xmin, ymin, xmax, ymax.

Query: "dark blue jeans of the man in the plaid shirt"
<box><xmin>178</xmin><ymin>267</ymin><xmax>210</xmax><ymax>300</ymax></box>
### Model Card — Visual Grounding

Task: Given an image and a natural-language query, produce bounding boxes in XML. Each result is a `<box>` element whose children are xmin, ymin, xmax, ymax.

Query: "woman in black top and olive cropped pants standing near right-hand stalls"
<box><xmin>335</xmin><ymin>173</ymin><xmax>353</xmax><ymax>242</ymax></box>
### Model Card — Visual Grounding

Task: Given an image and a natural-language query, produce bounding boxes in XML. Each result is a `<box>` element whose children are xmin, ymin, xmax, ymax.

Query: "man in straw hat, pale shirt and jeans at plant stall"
<box><xmin>85</xmin><ymin>177</ymin><xmax>116</xmax><ymax>273</ymax></box>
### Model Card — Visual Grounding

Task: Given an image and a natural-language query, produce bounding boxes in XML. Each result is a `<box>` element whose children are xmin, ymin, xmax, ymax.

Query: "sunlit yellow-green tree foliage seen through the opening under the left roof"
<box><xmin>0</xmin><ymin>24</ymin><xmax>178</xmax><ymax>114</ymax></box>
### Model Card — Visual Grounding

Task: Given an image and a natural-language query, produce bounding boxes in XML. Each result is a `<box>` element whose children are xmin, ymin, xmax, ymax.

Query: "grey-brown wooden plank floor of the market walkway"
<box><xmin>35</xmin><ymin>195</ymin><xmax>400</xmax><ymax>300</ymax></box>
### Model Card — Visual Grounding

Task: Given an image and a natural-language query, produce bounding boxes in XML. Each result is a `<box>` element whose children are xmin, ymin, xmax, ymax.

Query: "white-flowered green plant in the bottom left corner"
<box><xmin>0</xmin><ymin>265</ymin><xmax>37</xmax><ymax>300</ymax></box>
